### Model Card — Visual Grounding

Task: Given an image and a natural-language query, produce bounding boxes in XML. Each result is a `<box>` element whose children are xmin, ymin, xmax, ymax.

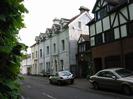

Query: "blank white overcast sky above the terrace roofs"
<box><xmin>19</xmin><ymin>0</ymin><xmax>96</xmax><ymax>52</ymax></box>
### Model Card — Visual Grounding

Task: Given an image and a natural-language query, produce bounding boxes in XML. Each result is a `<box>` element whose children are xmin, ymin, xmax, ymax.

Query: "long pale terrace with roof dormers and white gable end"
<box><xmin>31</xmin><ymin>7</ymin><xmax>91</xmax><ymax>75</ymax></box>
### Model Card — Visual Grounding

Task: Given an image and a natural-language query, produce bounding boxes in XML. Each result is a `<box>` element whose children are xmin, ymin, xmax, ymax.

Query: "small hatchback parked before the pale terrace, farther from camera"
<box><xmin>49</xmin><ymin>71</ymin><xmax>74</xmax><ymax>85</ymax></box>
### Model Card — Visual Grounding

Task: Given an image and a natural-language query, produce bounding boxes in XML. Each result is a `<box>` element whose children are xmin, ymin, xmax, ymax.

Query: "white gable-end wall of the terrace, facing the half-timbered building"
<box><xmin>69</xmin><ymin>12</ymin><xmax>91</xmax><ymax>65</ymax></box>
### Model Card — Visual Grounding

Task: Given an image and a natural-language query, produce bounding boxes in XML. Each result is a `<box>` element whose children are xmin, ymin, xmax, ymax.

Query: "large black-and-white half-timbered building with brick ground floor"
<box><xmin>88</xmin><ymin>0</ymin><xmax>133</xmax><ymax>71</ymax></box>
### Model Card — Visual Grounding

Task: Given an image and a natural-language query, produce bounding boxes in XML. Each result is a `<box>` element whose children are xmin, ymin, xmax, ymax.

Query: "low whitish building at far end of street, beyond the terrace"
<box><xmin>20</xmin><ymin>54</ymin><xmax>32</xmax><ymax>74</ymax></box>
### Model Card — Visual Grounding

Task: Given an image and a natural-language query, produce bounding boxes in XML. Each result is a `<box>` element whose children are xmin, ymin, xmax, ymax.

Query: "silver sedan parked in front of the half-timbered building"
<box><xmin>89</xmin><ymin>68</ymin><xmax>133</xmax><ymax>95</ymax></box>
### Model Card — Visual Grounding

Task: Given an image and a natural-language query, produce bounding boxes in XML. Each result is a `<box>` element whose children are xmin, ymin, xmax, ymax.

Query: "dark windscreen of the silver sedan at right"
<box><xmin>115</xmin><ymin>69</ymin><xmax>133</xmax><ymax>77</ymax></box>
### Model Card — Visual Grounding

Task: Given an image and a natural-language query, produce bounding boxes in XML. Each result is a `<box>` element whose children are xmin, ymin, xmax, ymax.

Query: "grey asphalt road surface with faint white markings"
<box><xmin>21</xmin><ymin>76</ymin><xmax>133</xmax><ymax>99</ymax></box>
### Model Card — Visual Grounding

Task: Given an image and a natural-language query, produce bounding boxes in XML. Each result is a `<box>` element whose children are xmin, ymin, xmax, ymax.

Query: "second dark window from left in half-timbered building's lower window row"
<box><xmin>104</xmin><ymin>30</ymin><xmax>114</xmax><ymax>42</ymax></box>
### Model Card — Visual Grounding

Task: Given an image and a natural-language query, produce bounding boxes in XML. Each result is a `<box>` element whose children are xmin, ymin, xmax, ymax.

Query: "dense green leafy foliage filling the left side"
<box><xmin>0</xmin><ymin>0</ymin><xmax>28</xmax><ymax>99</ymax></box>
